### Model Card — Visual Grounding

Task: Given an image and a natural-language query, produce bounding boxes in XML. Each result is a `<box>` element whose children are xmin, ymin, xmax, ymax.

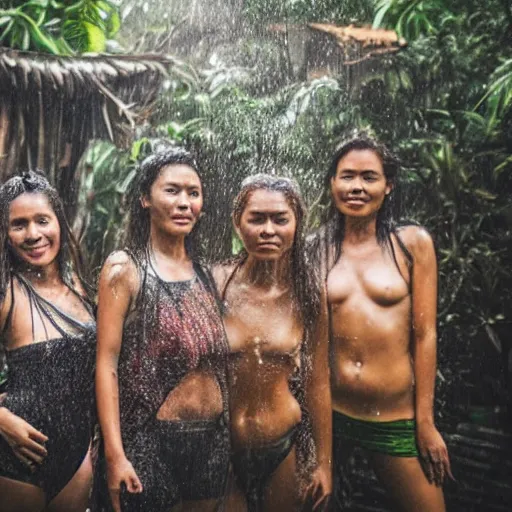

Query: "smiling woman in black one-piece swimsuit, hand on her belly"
<box><xmin>0</xmin><ymin>172</ymin><xmax>96</xmax><ymax>512</ymax></box>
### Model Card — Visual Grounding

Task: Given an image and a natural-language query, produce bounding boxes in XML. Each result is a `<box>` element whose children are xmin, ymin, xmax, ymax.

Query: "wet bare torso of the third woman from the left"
<box><xmin>225</xmin><ymin>282</ymin><xmax>302</xmax><ymax>449</ymax></box>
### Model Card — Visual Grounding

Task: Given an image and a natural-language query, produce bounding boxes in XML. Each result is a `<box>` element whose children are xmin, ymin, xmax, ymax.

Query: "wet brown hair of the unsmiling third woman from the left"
<box><xmin>233</xmin><ymin>174</ymin><xmax>320</xmax><ymax>343</ymax></box>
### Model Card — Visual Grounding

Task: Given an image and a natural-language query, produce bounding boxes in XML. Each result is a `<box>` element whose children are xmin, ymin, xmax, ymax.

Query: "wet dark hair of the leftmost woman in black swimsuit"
<box><xmin>0</xmin><ymin>171</ymin><xmax>93</xmax><ymax>300</ymax></box>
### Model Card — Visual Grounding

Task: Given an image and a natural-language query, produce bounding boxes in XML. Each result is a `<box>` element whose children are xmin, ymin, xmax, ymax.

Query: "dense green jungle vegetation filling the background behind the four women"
<box><xmin>0</xmin><ymin>0</ymin><xmax>512</xmax><ymax>410</ymax></box>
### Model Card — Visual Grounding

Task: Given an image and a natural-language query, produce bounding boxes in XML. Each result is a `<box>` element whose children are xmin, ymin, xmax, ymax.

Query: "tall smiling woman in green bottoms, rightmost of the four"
<box><xmin>317</xmin><ymin>136</ymin><xmax>451</xmax><ymax>512</ymax></box>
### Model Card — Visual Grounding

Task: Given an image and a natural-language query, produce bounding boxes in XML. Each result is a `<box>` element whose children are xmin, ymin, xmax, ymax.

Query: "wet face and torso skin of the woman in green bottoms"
<box><xmin>327</xmin><ymin>150</ymin><xmax>414</xmax><ymax>421</ymax></box>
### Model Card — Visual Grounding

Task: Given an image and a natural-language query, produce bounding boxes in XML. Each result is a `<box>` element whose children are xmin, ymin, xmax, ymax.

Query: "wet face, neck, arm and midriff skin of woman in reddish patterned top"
<box><xmin>96</xmin><ymin>164</ymin><xmax>222</xmax><ymax>512</ymax></box>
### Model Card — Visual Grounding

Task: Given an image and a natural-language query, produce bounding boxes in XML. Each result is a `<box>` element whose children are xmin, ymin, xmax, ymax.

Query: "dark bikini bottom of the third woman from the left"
<box><xmin>231</xmin><ymin>426</ymin><xmax>297</xmax><ymax>512</ymax></box>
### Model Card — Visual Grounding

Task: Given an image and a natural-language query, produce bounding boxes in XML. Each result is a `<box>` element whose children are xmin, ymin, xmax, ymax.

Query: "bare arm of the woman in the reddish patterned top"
<box><xmin>96</xmin><ymin>252</ymin><xmax>142</xmax><ymax>510</ymax></box>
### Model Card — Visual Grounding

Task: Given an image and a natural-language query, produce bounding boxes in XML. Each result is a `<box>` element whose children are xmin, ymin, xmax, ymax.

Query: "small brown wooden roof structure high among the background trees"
<box><xmin>268</xmin><ymin>23</ymin><xmax>407</xmax><ymax>79</ymax></box>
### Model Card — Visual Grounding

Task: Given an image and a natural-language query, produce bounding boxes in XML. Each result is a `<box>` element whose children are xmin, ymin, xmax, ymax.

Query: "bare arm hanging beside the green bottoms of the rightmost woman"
<box><xmin>404</xmin><ymin>227</ymin><xmax>451</xmax><ymax>485</ymax></box>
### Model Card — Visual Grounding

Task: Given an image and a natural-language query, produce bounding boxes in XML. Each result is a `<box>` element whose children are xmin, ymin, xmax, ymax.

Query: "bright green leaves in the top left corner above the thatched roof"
<box><xmin>0</xmin><ymin>0</ymin><xmax>120</xmax><ymax>55</ymax></box>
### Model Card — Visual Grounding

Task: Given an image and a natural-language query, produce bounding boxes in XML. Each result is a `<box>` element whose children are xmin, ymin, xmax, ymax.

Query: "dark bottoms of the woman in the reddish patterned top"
<box><xmin>93</xmin><ymin>419</ymin><xmax>230</xmax><ymax>512</ymax></box>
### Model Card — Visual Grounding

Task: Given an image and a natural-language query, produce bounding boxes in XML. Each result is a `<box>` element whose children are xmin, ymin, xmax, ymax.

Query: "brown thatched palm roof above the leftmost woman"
<box><xmin>0</xmin><ymin>48</ymin><xmax>172</xmax><ymax>210</ymax></box>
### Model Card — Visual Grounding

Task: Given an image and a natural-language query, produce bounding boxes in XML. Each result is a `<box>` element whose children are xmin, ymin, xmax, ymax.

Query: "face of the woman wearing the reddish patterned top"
<box><xmin>141</xmin><ymin>164</ymin><xmax>203</xmax><ymax>236</ymax></box>
